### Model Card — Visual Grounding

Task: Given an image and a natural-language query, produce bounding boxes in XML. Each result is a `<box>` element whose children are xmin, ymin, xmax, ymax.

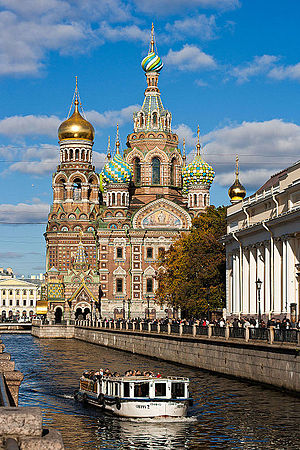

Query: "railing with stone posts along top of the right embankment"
<box><xmin>76</xmin><ymin>320</ymin><xmax>300</xmax><ymax>345</ymax></box>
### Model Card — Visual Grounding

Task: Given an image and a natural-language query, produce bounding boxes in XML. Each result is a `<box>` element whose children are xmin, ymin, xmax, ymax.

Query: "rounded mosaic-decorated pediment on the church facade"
<box><xmin>133</xmin><ymin>198</ymin><xmax>192</xmax><ymax>230</ymax></box>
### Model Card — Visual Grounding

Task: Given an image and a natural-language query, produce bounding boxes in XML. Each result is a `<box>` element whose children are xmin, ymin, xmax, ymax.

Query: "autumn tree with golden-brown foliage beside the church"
<box><xmin>156</xmin><ymin>206</ymin><xmax>226</xmax><ymax>317</ymax></box>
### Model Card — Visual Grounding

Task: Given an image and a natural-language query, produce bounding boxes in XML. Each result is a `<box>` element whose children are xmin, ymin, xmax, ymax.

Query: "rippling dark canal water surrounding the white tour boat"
<box><xmin>2</xmin><ymin>335</ymin><xmax>300</xmax><ymax>450</ymax></box>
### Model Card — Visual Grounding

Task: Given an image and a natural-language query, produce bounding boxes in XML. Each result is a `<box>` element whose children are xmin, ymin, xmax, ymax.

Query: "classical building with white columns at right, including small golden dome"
<box><xmin>224</xmin><ymin>158</ymin><xmax>300</xmax><ymax>320</ymax></box>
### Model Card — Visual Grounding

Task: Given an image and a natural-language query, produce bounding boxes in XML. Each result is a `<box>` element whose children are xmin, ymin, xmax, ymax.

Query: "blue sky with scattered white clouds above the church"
<box><xmin>0</xmin><ymin>0</ymin><xmax>300</xmax><ymax>275</ymax></box>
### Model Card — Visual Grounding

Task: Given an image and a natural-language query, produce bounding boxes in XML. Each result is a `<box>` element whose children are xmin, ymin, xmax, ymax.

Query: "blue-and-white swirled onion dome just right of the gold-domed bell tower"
<box><xmin>101</xmin><ymin>125</ymin><xmax>132</xmax><ymax>184</ymax></box>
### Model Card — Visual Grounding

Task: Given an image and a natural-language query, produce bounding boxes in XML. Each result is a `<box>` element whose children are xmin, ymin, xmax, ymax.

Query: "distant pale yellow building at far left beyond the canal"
<box><xmin>0</xmin><ymin>278</ymin><xmax>40</xmax><ymax>321</ymax></box>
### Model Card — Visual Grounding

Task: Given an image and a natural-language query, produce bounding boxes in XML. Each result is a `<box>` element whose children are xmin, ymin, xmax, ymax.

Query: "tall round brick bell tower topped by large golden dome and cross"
<box><xmin>45</xmin><ymin>77</ymin><xmax>99</xmax><ymax>272</ymax></box>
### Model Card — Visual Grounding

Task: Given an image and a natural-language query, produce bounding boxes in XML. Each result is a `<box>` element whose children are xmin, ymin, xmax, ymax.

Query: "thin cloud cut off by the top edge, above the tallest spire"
<box><xmin>134</xmin><ymin>0</ymin><xmax>240</xmax><ymax>14</ymax></box>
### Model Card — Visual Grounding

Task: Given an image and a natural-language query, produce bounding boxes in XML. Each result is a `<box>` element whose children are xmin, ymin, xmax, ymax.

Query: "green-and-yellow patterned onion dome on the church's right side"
<box><xmin>182</xmin><ymin>127</ymin><xmax>215</xmax><ymax>191</ymax></box>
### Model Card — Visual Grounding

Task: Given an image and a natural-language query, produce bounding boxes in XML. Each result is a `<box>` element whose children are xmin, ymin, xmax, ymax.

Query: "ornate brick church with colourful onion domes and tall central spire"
<box><xmin>43</xmin><ymin>27</ymin><xmax>214</xmax><ymax>322</ymax></box>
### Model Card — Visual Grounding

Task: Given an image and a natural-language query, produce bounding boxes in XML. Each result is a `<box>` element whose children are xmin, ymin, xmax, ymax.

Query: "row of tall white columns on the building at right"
<box><xmin>227</xmin><ymin>235</ymin><xmax>299</xmax><ymax>315</ymax></box>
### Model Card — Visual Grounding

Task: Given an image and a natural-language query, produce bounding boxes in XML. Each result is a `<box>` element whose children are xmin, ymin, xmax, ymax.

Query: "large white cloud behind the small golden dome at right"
<box><xmin>203</xmin><ymin>119</ymin><xmax>300</xmax><ymax>189</ymax></box>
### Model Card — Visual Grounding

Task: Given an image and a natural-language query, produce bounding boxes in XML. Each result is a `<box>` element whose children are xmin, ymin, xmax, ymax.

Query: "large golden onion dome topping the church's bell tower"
<box><xmin>58</xmin><ymin>98</ymin><xmax>95</xmax><ymax>141</ymax></box>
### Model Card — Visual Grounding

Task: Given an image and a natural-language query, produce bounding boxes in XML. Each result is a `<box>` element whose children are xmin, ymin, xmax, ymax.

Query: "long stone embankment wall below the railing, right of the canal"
<box><xmin>74</xmin><ymin>326</ymin><xmax>300</xmax><ymax>392</ymax></box>
